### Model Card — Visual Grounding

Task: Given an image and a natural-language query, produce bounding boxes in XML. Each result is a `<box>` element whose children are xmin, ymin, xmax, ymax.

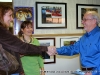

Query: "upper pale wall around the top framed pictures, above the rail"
<box><xmin>13</xmin><ymin>0</ymin><xmax>100</xmax><ymax>34</ymax></box>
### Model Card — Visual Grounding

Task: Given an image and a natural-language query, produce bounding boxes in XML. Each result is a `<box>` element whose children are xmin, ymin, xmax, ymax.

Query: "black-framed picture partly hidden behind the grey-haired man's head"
<box><xmin>76</xmin><ymin>4</ymin><xmax>100</xmax><ymax>29</ymax></box>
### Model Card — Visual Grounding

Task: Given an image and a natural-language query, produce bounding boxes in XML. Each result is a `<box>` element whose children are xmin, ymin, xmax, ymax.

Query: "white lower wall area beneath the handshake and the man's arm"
<box><xmin>45</xmin><ymin>55</ymin><xmax>80</xmax><ymax>75</ymax></box>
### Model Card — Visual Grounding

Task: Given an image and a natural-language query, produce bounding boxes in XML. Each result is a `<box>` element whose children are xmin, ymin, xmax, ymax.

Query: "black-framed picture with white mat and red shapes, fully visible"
<box><xmin>36</xmin><ymin>2</ymin><xmax>67</xmax><ymax>29</ymax></box>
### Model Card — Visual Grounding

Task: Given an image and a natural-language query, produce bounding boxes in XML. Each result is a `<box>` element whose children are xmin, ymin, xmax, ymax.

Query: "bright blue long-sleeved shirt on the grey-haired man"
<box><xmin>57</xmin><ymin>26</ymin><xmax>100</xmax><ymax>75</ymax></box>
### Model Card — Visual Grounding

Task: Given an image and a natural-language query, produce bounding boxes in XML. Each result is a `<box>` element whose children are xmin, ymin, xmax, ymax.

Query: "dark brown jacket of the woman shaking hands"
<box><xmin>0</xmin><ymin>25</ymin><xmax>47</xmax><ymax>73</ymax></box>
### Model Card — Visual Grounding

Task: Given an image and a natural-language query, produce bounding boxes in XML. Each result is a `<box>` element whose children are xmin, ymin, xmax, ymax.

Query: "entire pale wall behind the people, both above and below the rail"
<box><xmin>13</xmin><ymin>0</ymin><xmax>100</xmax><ymax>75</ymax></box>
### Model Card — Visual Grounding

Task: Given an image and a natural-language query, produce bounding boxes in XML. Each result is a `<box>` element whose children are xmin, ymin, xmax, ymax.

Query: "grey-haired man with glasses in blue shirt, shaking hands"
<box><xmin>56</xmin><ymin>11</ymin><xmax>100</xmax><ymax>75</ymax></box>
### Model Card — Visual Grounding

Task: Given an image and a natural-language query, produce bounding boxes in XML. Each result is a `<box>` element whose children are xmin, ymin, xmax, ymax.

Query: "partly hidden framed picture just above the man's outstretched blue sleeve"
<box><xmin>60</xmin><ymin>37</ymin><xmax>79</xmax><ymax>47</ymax></box>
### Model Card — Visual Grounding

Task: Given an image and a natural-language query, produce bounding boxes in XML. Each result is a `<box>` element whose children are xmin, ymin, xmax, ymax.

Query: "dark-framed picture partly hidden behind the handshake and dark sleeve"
<box><xmin>37</xmin><ymin>38</ymin><xmax>56</xmax><ymax>64</ymax></box>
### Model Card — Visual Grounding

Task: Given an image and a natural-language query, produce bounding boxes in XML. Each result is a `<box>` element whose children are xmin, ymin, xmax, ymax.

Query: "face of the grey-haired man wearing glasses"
<box><xmin>82</xmin><ymin>13</ymin><xmax>96</xmax><ymax>32</ymax></box>
